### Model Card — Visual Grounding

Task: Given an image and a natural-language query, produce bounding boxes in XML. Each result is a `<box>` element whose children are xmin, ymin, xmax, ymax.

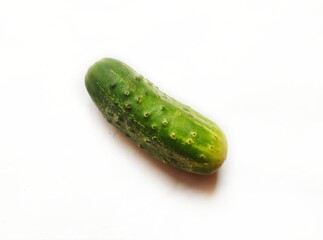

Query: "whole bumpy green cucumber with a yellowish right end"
<box><xmin>85</xmin><ymin>58</ymin><xmax>227</xmax><ymax>174</ymax></box>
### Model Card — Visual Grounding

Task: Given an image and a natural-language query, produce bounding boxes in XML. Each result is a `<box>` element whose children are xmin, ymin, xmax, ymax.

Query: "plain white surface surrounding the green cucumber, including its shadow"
<box><xmin>0</xmin><ymin>0</ymin><xmax>323</xmax><ymax>240</ymax></box>
